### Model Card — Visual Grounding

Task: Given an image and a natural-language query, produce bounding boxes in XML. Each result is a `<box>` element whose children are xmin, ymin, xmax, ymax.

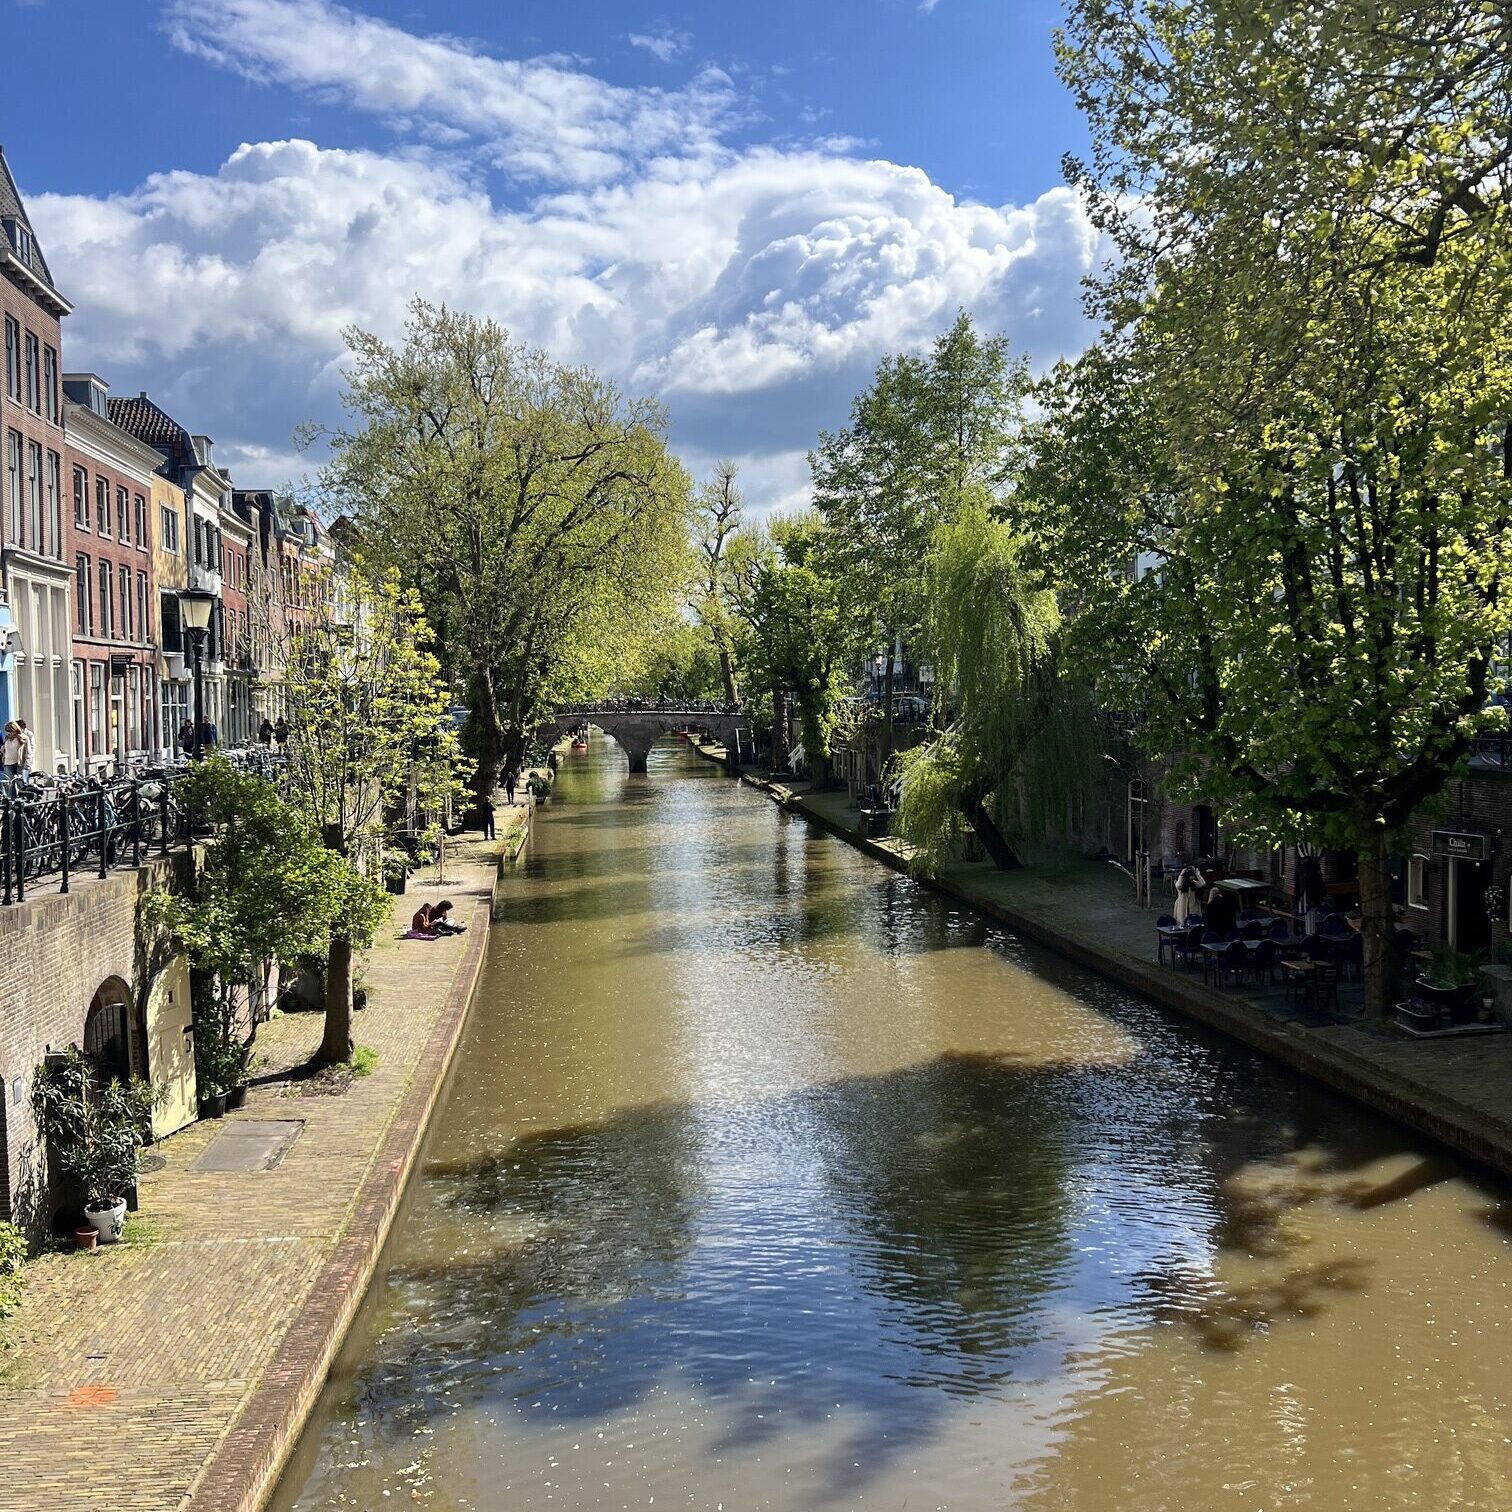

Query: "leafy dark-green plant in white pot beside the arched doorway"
<box><xmin>32</xmin><ymin>1049</ymin><xmax>153</xmax><ymax>1244</ymax></box>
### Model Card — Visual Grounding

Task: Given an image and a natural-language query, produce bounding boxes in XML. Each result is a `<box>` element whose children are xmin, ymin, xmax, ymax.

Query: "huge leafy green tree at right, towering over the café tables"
<box><xmin>1046</xmin><ymin>0</ymin><xmax>1512</xmax><ymax>1012</ymax></box>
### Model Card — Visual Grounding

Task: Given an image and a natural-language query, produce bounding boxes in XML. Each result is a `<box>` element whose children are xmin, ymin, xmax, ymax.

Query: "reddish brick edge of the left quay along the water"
<box><xmin>180</xmin><ymin>876</ymin><xmax>498</xmax><ymax>1512</ymax></box>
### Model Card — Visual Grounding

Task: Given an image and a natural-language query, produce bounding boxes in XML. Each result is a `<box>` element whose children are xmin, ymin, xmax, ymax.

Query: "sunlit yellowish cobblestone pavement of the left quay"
<box><xmin>0</xmin><ymin>813</ymin><xmax>510</xmax><ymax>1512</ymax></box>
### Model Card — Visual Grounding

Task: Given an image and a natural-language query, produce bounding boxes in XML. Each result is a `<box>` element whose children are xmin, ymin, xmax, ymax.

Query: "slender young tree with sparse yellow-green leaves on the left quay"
<box><xmin>286</xmin><ymin>572</ymin><xmax>460</xmax><ymax>1066</ymax></box>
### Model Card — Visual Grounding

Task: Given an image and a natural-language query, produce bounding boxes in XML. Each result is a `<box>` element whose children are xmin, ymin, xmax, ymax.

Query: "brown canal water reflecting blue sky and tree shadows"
<box><xmin>280</xmin><ymin>738</ymin><xmax>1512</xmax><ymax>1512</ymax></box>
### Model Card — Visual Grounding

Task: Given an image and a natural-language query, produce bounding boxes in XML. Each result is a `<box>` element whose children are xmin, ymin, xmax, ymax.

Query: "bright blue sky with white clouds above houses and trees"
<box><xmin>0</xmin><ymin>0</ymin><xmax>1101</xmax><ymax>505</ymax></box>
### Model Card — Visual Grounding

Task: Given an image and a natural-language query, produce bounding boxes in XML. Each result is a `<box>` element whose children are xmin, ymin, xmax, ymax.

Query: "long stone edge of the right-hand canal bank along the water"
<box><xmin>689</xmin><ymin>742</ymin><xmax>1512</xmax><ymax>1176</ymax></box>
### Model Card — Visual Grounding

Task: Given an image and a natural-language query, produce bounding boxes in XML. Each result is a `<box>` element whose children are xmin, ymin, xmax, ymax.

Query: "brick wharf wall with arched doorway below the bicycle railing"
<box><xmin>0</xmin><ymin>854</ymin><xmax>194</xmax><ymax>1235</ymax></box>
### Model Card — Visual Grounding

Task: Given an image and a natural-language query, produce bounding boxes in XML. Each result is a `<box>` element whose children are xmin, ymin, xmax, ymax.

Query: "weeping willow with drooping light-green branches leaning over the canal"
<box><xmin>895</xmin><ymin>500</ymin><xmax>1099</xmax><ymax>872</ymax></box>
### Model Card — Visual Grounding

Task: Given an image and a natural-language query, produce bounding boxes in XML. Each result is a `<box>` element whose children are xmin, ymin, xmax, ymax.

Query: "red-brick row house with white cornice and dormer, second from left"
<box><xmin>64</xmin><ymin>373</ymin><xmax>163</xmax><ymax>771</ymax></box>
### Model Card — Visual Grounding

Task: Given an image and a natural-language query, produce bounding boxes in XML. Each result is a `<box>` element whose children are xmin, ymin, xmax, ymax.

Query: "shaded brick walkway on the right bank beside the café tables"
<box><xmin>703</xmin><ymin>747</ymin><xmax>1512</xmax><ymax>1175</ymax></box>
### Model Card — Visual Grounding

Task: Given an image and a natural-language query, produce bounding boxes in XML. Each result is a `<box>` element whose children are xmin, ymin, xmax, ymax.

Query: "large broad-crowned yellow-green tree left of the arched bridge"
<box><xmin>325</xmin><ymin>301</ymin><xmax>689</xmax><ymax>798</ymax></box>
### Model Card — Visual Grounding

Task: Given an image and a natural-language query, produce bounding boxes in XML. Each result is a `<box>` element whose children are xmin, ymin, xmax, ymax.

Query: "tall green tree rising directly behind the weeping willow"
<box><xmin>809</xmin><ymin>313</ymin><xmax>1030</xmax><ymax>751</ymax></box>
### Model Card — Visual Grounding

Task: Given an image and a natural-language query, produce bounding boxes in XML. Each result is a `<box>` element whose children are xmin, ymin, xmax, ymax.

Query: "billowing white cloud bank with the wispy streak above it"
<box><xmin>30</xmin><ymin>0</ymin><xmax>1099</xmax><ymax>507</ymax></box>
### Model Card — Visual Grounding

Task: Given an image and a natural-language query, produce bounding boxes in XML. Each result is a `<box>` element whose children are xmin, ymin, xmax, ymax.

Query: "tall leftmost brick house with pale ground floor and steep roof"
<box><xmin>0</xmin><ymin>151</ymin><xmax>71</xmax><ymax>771</ymax></box>
